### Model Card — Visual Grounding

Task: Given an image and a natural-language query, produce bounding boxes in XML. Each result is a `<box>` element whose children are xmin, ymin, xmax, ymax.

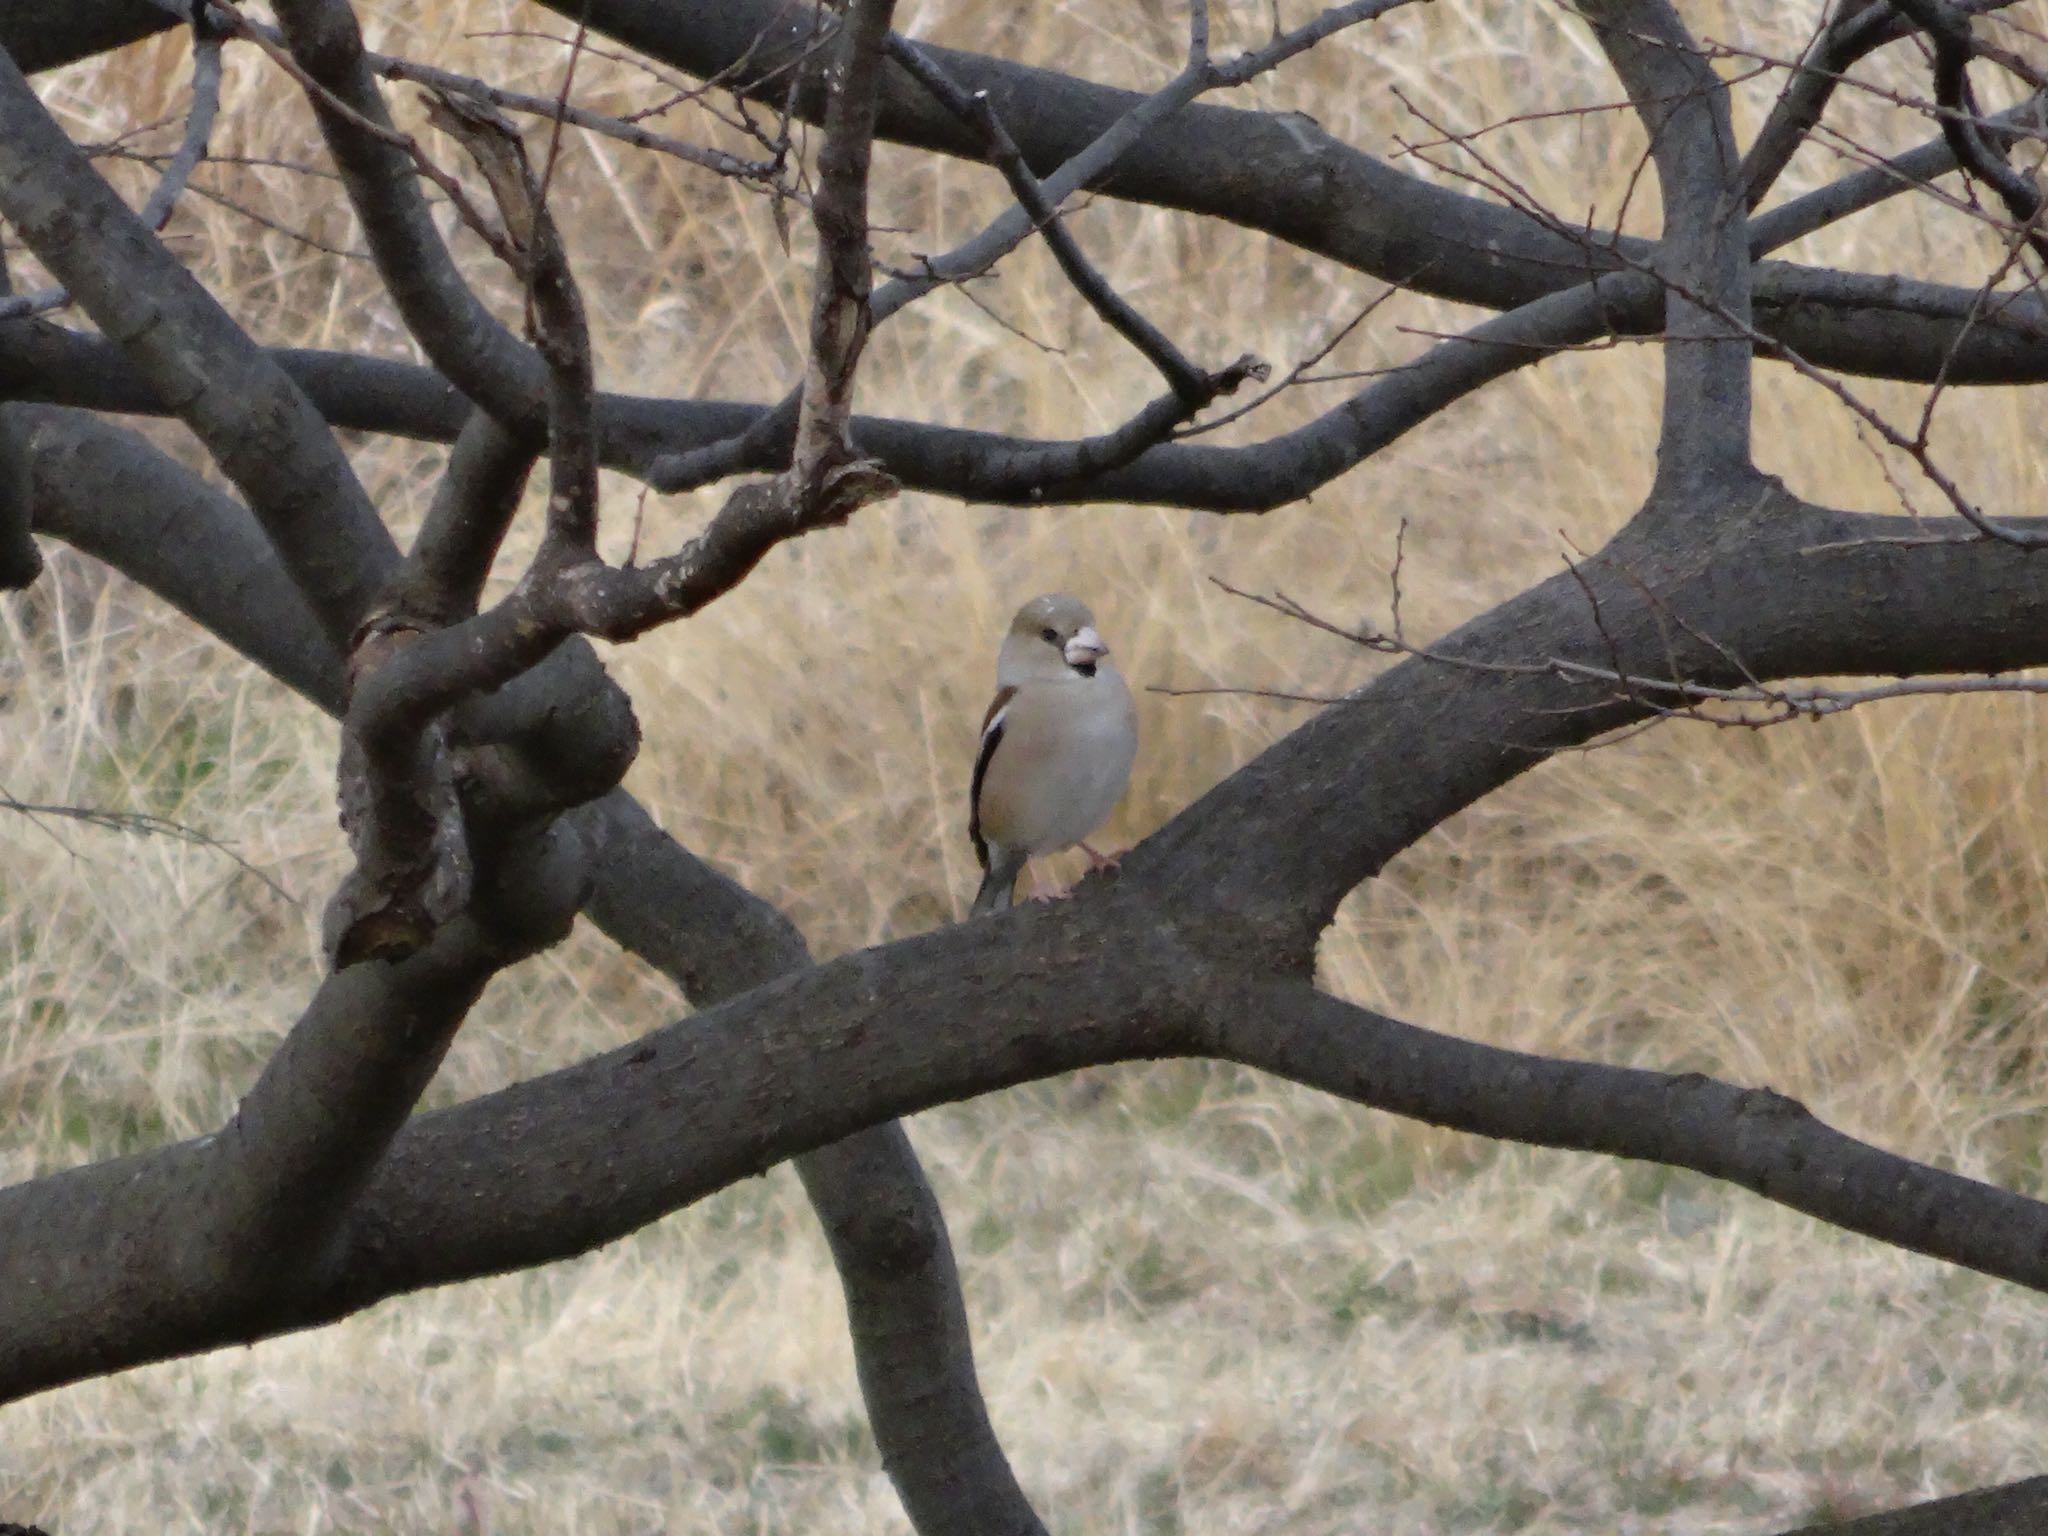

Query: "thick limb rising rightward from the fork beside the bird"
<box><xmin>1124</xmin><ymin>483</ymin><xmax>2048</xmax><ymax>950</ymax></box>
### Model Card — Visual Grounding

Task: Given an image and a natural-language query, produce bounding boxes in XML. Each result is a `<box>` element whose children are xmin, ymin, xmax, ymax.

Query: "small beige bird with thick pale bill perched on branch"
<box><xmin>967</xmin><ymin>592</ymin><xmax>1139</xmax><ymax>918</ymax></box>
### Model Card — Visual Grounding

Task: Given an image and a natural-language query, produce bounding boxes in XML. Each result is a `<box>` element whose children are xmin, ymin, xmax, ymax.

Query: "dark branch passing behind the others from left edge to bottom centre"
<box><xmin>16</xmin><ymin>421</ymin><xmax>1038</xmax><ymax>1532</ymax></box>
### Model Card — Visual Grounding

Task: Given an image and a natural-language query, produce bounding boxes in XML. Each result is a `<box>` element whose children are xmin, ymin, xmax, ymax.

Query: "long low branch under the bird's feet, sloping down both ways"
<box><xmin>12</xmin><ymin>835</ymin><xmax>2048</xmax><ymax>1417</ymax></box>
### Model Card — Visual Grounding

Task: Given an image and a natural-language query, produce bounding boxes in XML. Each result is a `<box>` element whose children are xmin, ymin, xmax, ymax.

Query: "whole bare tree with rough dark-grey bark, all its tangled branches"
<box><xmin>0</xmin><ymin>0</ymin><xmax>2048</xmax><ymax>1536</ymax></box>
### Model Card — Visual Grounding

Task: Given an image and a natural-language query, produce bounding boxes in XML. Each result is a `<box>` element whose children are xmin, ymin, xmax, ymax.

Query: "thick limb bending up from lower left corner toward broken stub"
<box><xmin>0</xmin><ymin>860</ymin><xmax>567</xmax><ymax>1395</ymax></box>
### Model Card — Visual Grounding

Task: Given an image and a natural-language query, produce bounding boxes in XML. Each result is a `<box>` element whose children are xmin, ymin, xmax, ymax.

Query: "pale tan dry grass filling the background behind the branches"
<box><xmin>0</xmin><ymin>0</ymin><xmax>2048</xmax><ymax>1536</ymax></box>
